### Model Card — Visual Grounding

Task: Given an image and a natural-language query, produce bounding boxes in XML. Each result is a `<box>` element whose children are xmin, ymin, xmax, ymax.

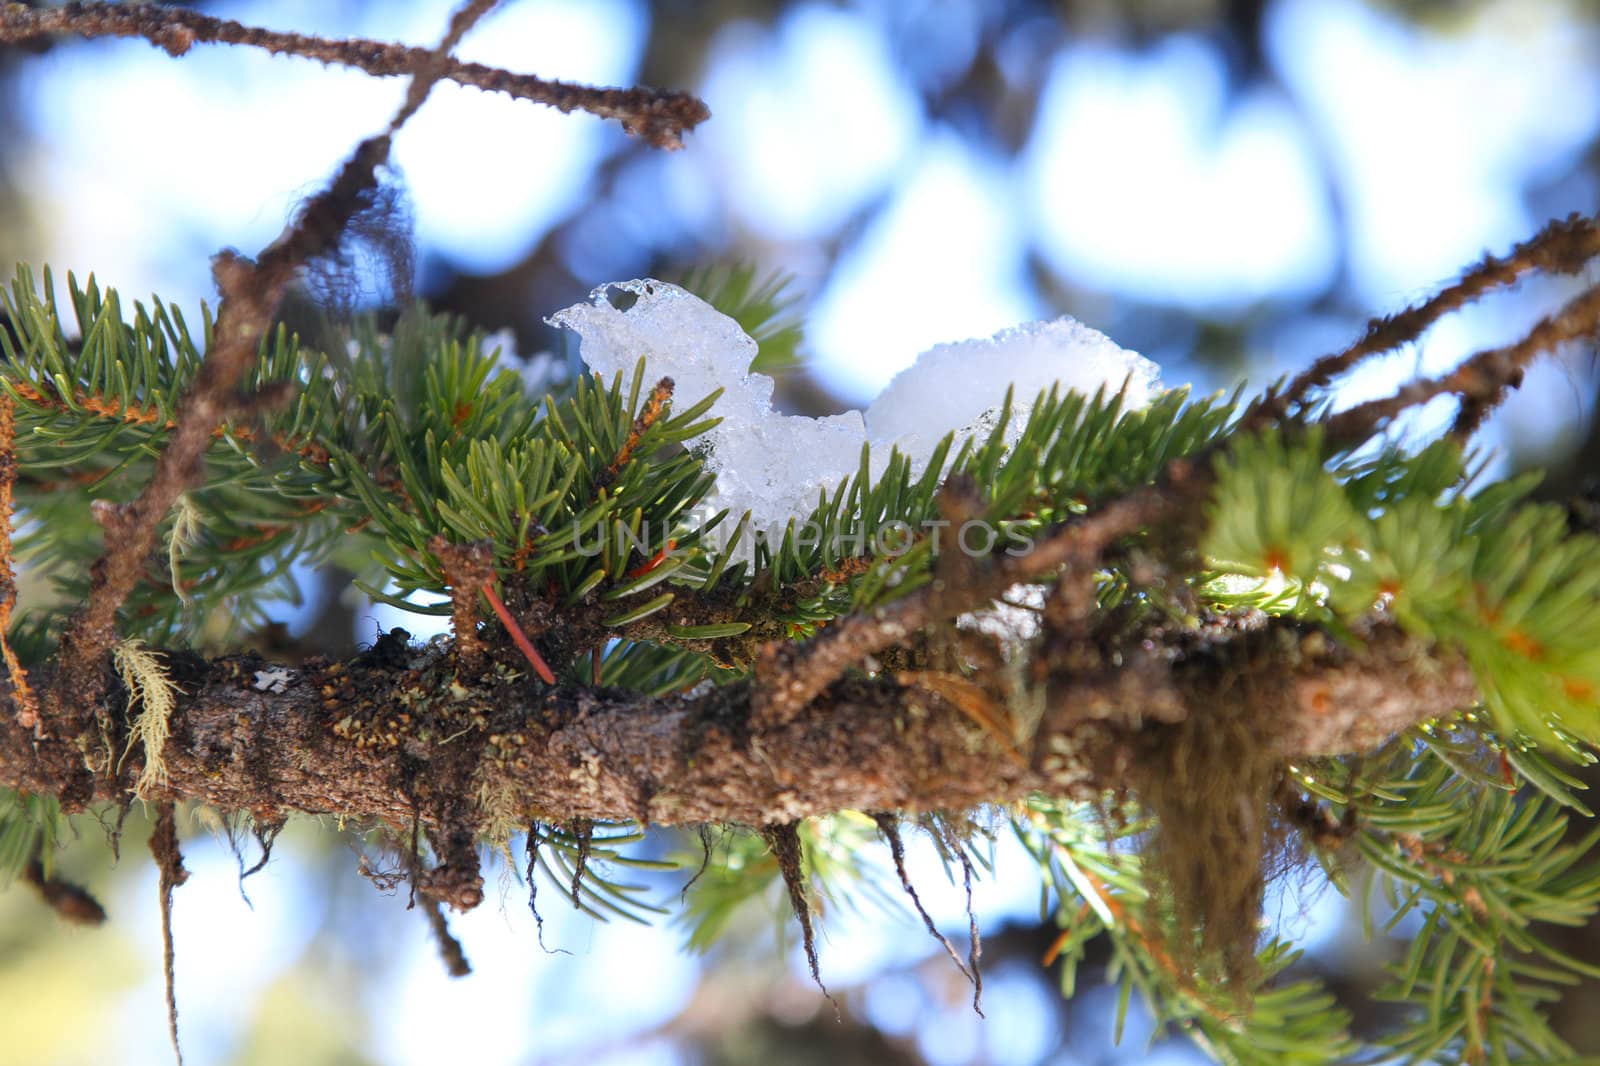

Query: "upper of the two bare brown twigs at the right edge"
<box><xmin>1256</xmin><ymin>214</ymin><xmax>1600</xmax><ymax>424</ymax></box>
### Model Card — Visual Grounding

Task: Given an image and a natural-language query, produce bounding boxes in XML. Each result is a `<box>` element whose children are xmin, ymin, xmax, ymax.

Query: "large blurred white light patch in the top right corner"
<box><xmin>1267</xmin><ymin>0</ymin><xmax>1600</xmax><ymax>302</ymax></box>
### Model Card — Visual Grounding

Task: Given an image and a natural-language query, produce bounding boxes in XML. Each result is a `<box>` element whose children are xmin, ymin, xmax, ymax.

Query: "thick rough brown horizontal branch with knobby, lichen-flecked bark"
<box><xmin>0</xmin><ymin>627</ymin><xmax>1477</xmax><ymax>847</ymax></box>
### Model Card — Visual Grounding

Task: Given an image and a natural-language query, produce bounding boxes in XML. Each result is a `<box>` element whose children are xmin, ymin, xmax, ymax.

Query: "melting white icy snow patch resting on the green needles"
<box><xmin>549</xmin><ymin>279</ymin><xmax>1160</xmax><ymax>533</ymax></box>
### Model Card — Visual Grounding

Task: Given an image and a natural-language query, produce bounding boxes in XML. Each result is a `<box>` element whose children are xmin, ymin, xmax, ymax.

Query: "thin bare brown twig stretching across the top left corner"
<box><xmin>0</xmin><ymin>3</ymin><xmax>710</xmax><ymax>149</ymax></box>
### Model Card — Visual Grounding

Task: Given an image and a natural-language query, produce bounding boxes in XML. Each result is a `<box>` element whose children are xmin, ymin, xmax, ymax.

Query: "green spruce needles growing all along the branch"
<box><xmin>0</xmin><ymin>256</ymin><xmax>1600</xmax><ymax>1064</ymax></box>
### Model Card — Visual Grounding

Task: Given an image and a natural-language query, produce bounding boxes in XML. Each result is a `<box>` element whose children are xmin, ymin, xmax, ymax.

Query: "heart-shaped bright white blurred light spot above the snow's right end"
<box><xmin>1027</xmin><ymin>38</ymin><xmax>1334</xmax><ymax>307</ymax></box>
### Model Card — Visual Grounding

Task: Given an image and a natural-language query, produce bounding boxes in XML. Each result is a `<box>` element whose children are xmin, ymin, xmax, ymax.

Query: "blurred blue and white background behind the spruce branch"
<box><xmin>0</xmin><ymin>0</ymin><xmax>1600</xmax><ymax>1066</ymax></box>
